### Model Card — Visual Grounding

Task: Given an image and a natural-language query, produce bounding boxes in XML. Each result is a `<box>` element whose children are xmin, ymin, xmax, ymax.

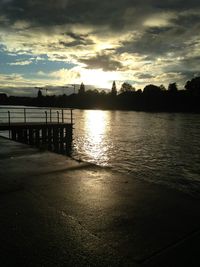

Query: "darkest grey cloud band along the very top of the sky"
<box><xmin>0</xmin><ymin>0</ymin><xmax>200</xmax><ymax>28</ymax></box>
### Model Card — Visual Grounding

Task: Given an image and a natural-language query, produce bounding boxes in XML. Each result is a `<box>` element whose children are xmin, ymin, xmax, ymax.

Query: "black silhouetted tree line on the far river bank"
<box><xmin>0</xmin><ymin>77</ymin><xmax>200</xmax><ymax>113</ymax></box>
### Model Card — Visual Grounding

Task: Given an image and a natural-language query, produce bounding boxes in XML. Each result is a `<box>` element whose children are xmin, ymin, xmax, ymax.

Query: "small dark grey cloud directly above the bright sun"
<box><xmin>80</xmin><ymin>55</ymin><xmax>122</xmax><ymax>71</ymax></box>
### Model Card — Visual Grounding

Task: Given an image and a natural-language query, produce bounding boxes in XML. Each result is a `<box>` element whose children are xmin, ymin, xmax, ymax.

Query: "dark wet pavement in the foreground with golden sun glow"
<box><xmin>0</xmin><ymin>138</ymin><xmax>200</xmax><ymax>267</ymax></box>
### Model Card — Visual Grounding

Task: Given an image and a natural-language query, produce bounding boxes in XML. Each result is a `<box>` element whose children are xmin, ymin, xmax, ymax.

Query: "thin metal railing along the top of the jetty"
<box><xmin>0</xmin><ymin>106</ymin><xmax>73</xmax><ymax>125</ymax></box>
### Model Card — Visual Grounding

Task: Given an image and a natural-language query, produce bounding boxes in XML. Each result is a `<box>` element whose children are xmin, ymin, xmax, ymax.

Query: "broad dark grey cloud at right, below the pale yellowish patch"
<box><xmin>117</xmin><ymin>18</ymin><xmax>200</xmax><ymax>59</ymax></box>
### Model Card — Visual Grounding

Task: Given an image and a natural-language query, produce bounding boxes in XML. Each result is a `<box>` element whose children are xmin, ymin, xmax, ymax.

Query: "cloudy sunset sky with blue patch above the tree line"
<box><xmin>0</xmin><ymin>0</ymin><xmax>200</xmax><ymax>94</ymax></box>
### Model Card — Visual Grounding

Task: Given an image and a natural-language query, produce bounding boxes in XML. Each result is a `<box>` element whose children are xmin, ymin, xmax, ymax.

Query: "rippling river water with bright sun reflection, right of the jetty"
<box><xmin>0</xmin><ymin>107</ymin><xmax>200</xmax><ymax>196</ymax></box>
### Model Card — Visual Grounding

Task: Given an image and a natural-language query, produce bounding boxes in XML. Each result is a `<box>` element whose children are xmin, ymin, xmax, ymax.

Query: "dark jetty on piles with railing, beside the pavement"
<box><xmin>0</xmin><ymin>107</ymin><xmax>73</xmax><ymax>153</ymax></box>
